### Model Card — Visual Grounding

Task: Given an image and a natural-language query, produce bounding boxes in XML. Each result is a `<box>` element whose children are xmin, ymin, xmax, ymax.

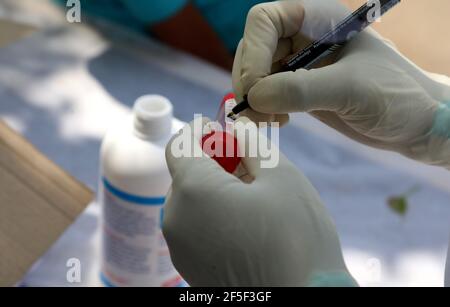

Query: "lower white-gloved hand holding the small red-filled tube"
<box><xmin>163</xmin><ymin>118</ymin><xmax>356</xmax><ymax>286</ymax></box>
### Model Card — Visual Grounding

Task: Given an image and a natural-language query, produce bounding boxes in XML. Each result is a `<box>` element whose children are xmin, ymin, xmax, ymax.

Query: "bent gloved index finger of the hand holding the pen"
<box><xmin>240</xmin><ymin>1</ymin><xmax>305</xmax><ymax>93</ymax></box>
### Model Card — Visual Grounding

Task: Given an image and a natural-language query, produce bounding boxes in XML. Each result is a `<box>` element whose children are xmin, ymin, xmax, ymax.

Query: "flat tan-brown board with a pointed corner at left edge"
<box><xmin>0</xmin><ymin>122</ymin><xmax>93</xmax><ymax>286</ymax></box>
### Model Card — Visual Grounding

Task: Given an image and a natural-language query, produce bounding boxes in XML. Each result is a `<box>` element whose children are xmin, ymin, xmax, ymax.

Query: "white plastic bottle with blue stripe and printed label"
<box><xmin>99</xmin><ymin>95</ymin><xmax>184</xmax><ymax>287</ymax></box>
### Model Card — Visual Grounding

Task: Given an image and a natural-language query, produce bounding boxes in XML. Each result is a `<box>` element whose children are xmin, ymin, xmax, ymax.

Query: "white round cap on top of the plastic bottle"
<box><xmin>133</xmin><ymin>95</ymin><xmax>173</xmax><ymax>140</ymax></box>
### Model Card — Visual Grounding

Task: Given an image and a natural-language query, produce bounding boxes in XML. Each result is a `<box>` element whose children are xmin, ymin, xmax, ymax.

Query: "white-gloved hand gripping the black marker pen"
<box><xmin>233</xmin><ymin>0</ymin><xmax>450</xmax><ymax>168</ymax></box>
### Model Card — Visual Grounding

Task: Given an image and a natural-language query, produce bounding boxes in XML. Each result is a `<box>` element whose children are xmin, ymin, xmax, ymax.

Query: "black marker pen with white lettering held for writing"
<box><xmin>227</xmin><ymin>0</ymin><xmax>401</xmax><ymax>119</ymax></box>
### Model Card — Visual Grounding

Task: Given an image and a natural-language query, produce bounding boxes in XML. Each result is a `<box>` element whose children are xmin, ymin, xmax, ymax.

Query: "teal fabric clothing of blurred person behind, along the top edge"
<box><xmin>55</xmin><ymin>0</ymin><xmax>268</xmax><ymax>52</ymax></box>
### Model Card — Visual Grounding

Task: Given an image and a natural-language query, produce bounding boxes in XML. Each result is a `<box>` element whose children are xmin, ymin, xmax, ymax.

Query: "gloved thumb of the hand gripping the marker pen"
<box><xmin>248</xmin><ymin>64</ymin><xmax>348</xmax><ymax>114</ymax></box>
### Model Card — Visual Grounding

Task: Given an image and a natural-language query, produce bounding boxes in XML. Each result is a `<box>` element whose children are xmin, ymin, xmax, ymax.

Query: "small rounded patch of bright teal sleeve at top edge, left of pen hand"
<box><xmin>122</xmin><ymin>0</ymin><xmax>188</xmax><ymax>25</ymax></box>
